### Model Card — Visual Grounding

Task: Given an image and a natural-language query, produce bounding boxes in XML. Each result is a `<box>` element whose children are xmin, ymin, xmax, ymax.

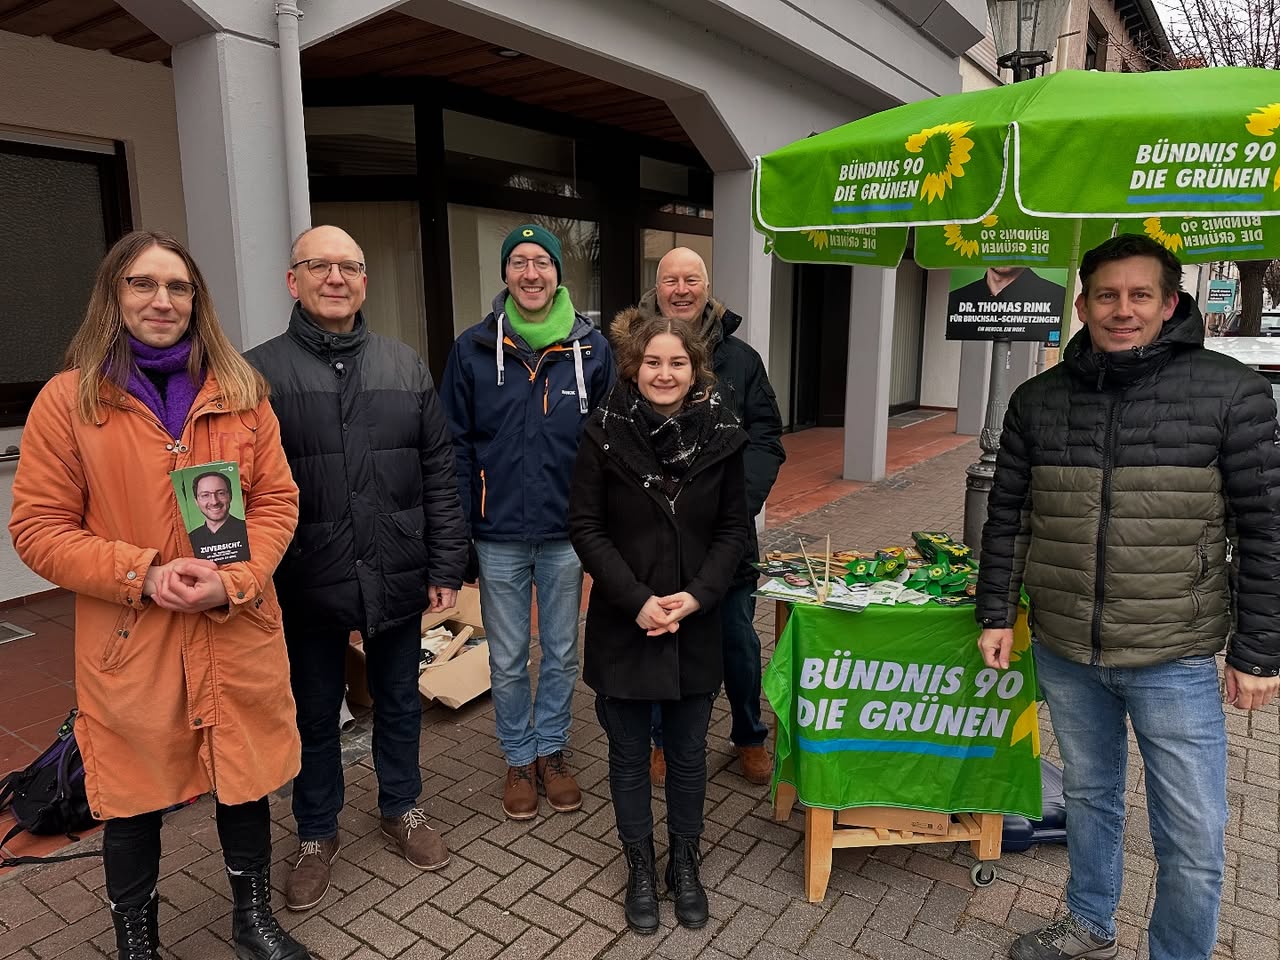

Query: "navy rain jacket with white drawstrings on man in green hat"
<box><xmin>440</xmin><ymin>288</ymin><xmax>614</xmax><ymax>543</ymax></box>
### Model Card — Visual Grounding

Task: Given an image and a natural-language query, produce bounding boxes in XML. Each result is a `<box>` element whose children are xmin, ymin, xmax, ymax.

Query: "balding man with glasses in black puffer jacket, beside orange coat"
<box><xmin>246</xmin><ymin>227</ymin><xmax>468</xmax><ymax>910</ymax></box>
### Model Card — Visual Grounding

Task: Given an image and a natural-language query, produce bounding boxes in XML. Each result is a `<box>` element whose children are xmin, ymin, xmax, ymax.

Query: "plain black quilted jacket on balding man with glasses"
<box><xmin>244</xmin><ymin>305</ymin><xmax>467</xmax><ymax>635</ymax></box>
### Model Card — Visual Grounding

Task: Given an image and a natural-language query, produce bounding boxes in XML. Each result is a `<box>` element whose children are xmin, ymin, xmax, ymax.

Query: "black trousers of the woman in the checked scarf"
<box><xmin>595</xmin><ymin>692</ymin><xmax>716</xmax><ymax>844</ymax></box>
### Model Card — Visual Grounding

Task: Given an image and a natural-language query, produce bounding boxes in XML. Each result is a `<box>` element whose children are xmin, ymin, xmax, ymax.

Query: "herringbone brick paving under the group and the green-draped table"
<box><xmin>0</xmin><ymin>444</ymin><xmax>1280</xmax><ymax>960</ymax></box>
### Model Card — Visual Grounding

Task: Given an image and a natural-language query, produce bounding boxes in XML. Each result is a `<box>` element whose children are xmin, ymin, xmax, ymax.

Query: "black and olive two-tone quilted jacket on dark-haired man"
<box><xmin>977</xmin><ymin>293</ymin><xmax>1280</xmax><ymax>673</ymax></box>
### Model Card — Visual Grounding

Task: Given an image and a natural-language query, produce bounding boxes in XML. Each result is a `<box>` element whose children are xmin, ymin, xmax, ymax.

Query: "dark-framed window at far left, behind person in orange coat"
<box><xmin>0</xmin><ymin>140</ymin><xmax>129</xmax><ymax>426</ymax></box>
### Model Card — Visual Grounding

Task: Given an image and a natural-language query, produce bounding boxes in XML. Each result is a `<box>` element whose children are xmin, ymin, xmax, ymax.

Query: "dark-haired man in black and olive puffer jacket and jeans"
<box><xmin>977</xmin><ymin>234</ymin><xmax>1280</xmax><ymax>960</ymax></box>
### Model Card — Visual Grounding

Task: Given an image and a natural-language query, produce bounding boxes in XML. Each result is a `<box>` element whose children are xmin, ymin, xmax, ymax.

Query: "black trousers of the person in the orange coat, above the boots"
<box><xmin>102</xmin><ymin>796</ymin><xmax>271</xmax><ymax>910</ymax></box>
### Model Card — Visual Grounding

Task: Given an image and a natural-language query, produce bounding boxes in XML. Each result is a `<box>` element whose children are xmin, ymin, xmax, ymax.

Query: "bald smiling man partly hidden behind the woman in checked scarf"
<box><xmin>640</xmin><ymin>247</ymin><xmax>787</xmax><ymax>786</ymax></box>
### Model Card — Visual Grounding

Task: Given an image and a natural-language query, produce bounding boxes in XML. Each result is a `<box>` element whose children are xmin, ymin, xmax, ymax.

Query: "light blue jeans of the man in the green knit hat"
<box><xmin>476</xmin><ymin>540</ymin><xmax>582</xmax><ymax>767</ymax></box>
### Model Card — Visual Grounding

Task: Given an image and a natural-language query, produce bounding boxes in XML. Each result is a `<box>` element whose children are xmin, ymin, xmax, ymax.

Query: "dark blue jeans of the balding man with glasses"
<box><xmin>284</xmin><ymin>611</ymin><xmax>422</xmax><ymax>840</ymax></box>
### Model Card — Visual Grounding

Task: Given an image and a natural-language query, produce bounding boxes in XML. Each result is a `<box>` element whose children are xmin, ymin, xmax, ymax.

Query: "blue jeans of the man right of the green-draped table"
<box><xmin>1034</xmin><ymin>643</ymin><xmax>1226</xmax><ymax>960</ymax></box>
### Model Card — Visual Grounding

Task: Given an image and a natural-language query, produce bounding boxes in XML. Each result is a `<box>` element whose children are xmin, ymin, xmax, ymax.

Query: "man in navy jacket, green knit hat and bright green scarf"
<box><xmin>442</xmin><ymin>224</ymin><xmax>613</xmax><ymax>820</ymax></box>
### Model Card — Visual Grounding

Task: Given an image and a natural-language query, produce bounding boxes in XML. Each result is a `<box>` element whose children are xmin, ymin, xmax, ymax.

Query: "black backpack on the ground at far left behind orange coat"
<box><xmin>0</xmin><ymin>709</ymin><xmax>101</xmax><ymax>867</ymax></box>
